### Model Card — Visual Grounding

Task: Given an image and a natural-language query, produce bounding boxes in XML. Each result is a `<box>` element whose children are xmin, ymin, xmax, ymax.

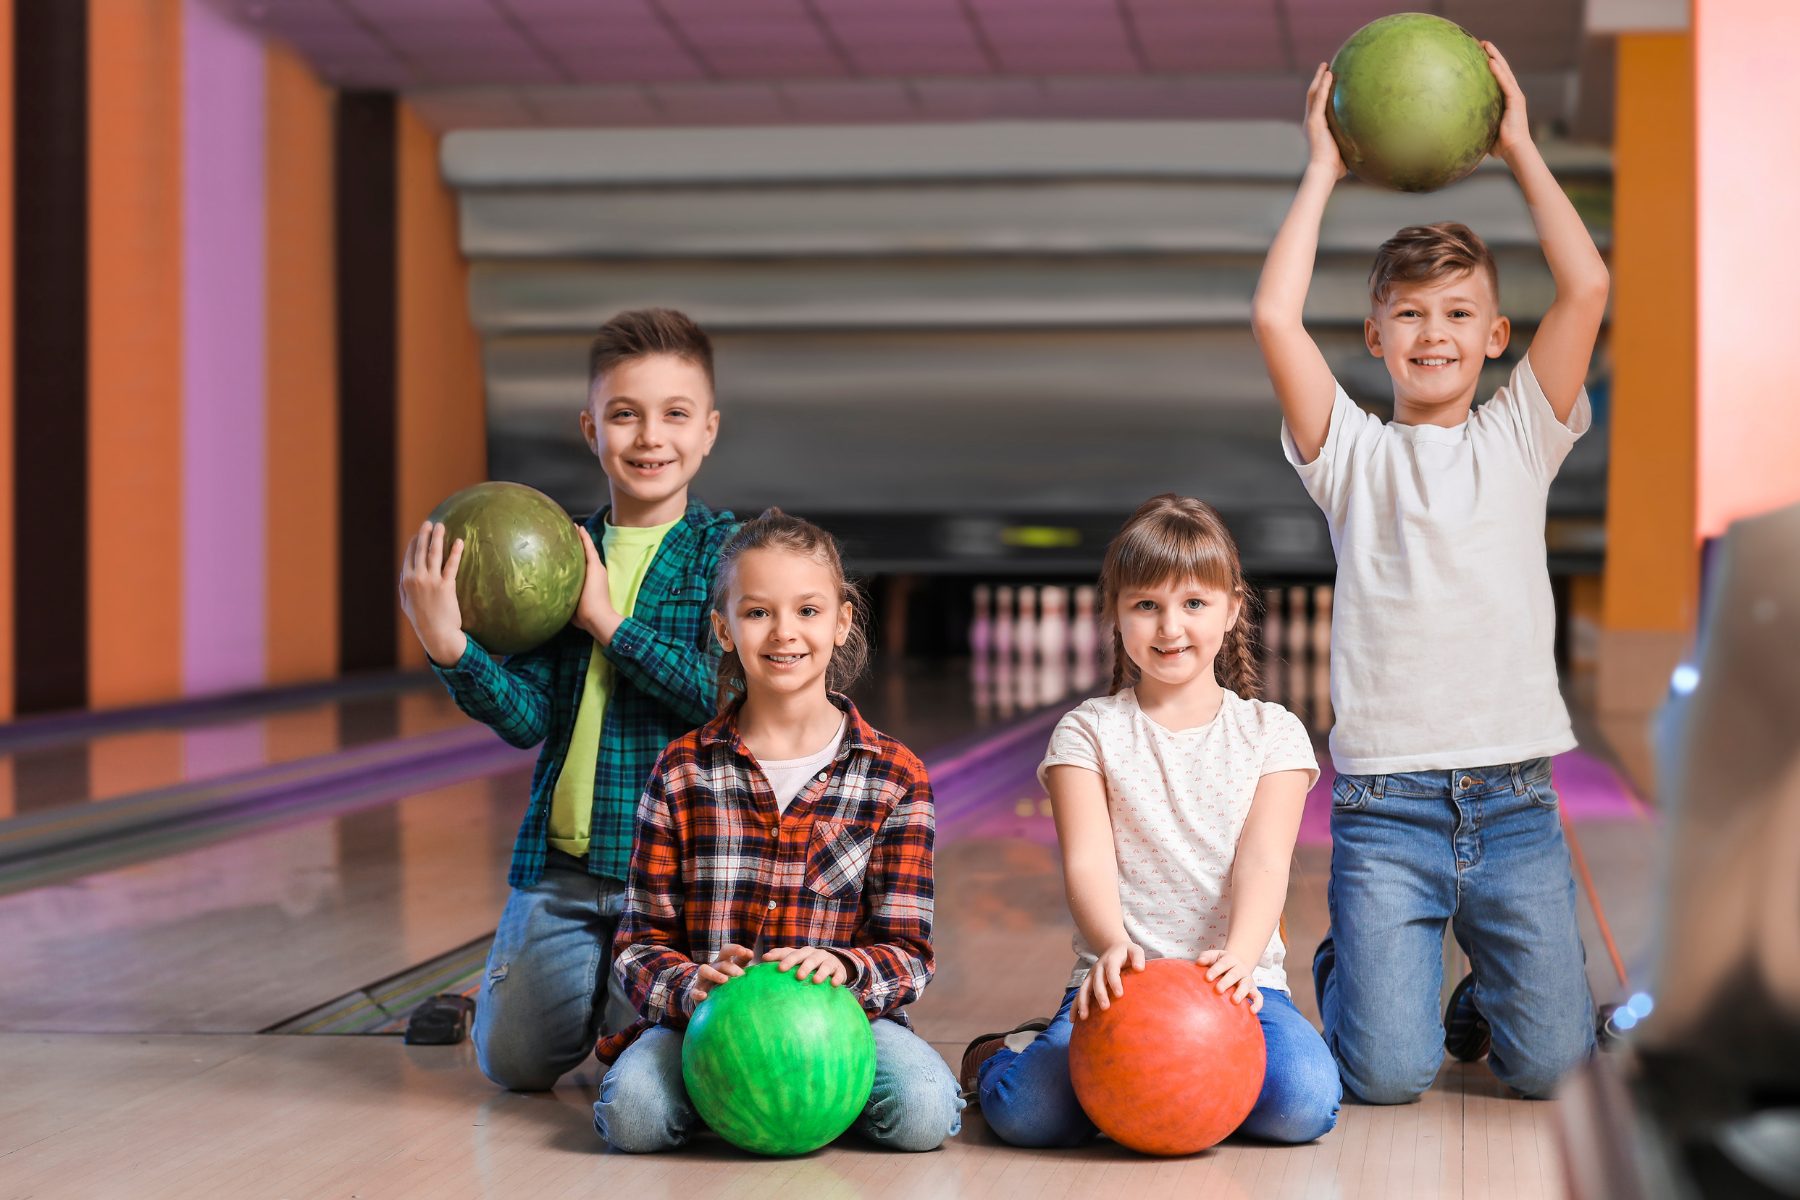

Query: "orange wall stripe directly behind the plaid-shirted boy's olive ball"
<box><xmin>394</xmin><ymin>103</ymin><xmax>488</xmax><ymax>667</ymax></box>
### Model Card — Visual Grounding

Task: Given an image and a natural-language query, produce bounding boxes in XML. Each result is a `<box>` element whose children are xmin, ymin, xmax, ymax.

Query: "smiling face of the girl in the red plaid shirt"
<box><xmin>713</xmin><ymin>549</ymin><xmax>853</xmax><ymax>698</ymax></box>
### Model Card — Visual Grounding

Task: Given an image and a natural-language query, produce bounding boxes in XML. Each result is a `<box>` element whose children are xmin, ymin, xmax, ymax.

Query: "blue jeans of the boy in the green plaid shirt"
<box><xmin>473</xmin><ymin>851</ymin><xmax>634</xmax><ymax>1092</ymax></box>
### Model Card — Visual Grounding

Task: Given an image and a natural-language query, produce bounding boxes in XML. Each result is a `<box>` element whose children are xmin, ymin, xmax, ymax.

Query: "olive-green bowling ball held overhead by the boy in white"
<box><xmin>1325</xmin><ymin>13</ymin><xmax>1507</xmax><ymax>193</ymax></box>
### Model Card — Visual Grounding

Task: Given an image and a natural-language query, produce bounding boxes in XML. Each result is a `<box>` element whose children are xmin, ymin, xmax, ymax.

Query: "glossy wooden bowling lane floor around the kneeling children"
<box><xmin>0</xmin><ymin>672</ymin><xmax>1652</xmax><ymax>1200</ymax></box>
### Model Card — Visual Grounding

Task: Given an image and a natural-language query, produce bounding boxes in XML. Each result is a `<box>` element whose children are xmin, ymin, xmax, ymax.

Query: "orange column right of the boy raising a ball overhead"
<box><xmin>1598</xmin><ymin>32</ymin><xmax>1699</xmax><ymax>788</ymax></box>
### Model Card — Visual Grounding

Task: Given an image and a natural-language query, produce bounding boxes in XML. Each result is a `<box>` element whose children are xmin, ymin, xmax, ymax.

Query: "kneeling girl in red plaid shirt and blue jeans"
<box><xmin>594</xmin><ymin>509</ymin><xmax>963</xmax><ymax>1151</ymax></box>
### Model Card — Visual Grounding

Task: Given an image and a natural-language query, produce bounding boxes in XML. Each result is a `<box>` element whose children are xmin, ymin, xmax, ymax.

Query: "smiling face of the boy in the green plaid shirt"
<box><xmin>581</xmin><ymin>354</ymin><xmax>718</xmax><ymax>515</ymax></box>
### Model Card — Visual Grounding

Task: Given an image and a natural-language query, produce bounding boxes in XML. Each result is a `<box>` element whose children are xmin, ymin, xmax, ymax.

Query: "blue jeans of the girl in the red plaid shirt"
<box><xmin>594</xmin><ymin>1016</ymin><xmax>963</xmax><ymax>1153</ymax></box>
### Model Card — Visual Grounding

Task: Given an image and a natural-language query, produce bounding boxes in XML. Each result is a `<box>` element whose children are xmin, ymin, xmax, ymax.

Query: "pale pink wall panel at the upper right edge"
<box><xmin>1694</xmin><ymin>0</ymin><xmax>1800</xmax><ymax>536</ymax></box>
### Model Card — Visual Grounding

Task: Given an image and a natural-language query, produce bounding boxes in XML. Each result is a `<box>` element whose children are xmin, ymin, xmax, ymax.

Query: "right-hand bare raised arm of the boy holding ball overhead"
<box><xmin>1481</xmin><ymin>41</ymin><xmax>1611</xmax><ymax>423</ymax></box>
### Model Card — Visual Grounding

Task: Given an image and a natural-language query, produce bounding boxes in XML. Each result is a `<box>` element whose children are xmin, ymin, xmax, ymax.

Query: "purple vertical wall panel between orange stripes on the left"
<box><xmin>182</xmin><ymin>0</ymin><xmax>268</xmax><ymax>694</ymax></box>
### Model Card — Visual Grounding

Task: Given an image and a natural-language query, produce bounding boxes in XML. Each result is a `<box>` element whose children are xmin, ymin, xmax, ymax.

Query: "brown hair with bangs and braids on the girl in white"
<box><xmin>1100</xmin><ymin>491</ymin><xmax>1262</xmax><ymax>700</ymax></box>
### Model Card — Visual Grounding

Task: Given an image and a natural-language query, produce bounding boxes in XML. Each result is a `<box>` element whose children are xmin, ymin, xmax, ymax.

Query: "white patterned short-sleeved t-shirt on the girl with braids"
<box><xmin>1037</xmin><ymin>687</ymin><xmax>1319</xmax><ymax>991</ymax></box>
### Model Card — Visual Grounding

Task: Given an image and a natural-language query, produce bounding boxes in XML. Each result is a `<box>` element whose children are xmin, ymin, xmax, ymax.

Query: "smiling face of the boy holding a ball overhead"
<box><xmin>1363</xmin><ymin>272</ymin><xmax>1512</xmax><ymax>425</ymax></box>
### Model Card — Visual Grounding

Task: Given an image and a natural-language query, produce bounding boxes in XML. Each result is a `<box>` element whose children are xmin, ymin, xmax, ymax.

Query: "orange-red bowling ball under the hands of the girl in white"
<box><xmin>1069</xmin><ymin>959</ymin><xmax>1269</xmax><ymax>1155</ymax></box>
